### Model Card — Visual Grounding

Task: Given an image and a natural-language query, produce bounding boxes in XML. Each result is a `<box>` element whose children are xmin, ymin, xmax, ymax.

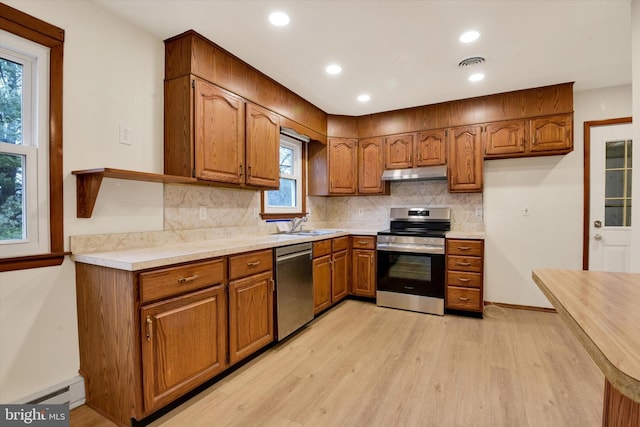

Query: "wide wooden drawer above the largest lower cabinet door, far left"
<box><xmin>140</xmin><ymin>258</ymin><xmax>226</xmax><ymax>303</ymax></box>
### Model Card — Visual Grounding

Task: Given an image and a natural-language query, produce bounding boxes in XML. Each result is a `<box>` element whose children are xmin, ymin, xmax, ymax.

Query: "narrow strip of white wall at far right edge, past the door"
<box><xmin>630</xmin><ymin>0</ymin><xmax>640</xmax><ymax>273</ymax></box>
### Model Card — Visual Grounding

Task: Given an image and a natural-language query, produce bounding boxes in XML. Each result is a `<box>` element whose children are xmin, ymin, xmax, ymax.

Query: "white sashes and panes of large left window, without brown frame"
<box><xmin>0</xmin><ymin>31</ymin><xmax>49</xmax><ymax>257</ymax></box>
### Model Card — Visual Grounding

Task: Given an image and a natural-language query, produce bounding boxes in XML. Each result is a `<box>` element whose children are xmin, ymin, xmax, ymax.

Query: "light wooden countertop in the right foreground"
<box><xmin>532</xmin><ymin>269</ymin><xmax>640</xmax><ymax>402</ymax></box>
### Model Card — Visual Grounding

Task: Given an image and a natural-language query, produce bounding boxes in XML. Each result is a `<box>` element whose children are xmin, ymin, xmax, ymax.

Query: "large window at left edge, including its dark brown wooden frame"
<box><xmin>0</xmin><ymin>3</ymin><xmax>65</xmax><ymax>271</ymax></box>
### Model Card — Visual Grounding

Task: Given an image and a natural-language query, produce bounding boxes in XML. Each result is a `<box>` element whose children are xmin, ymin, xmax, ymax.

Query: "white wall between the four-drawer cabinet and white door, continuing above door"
<box><xmin>484</xmin><ymin>86</ymin><xmax>631</xmax><ymax>307</ymax></box>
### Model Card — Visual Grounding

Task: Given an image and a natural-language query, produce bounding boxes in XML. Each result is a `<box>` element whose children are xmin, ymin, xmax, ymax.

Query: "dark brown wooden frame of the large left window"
<box><xmin>0</xmin><ymin>3</ymin><xmax>69</xmax><ymax>272</ymax></box>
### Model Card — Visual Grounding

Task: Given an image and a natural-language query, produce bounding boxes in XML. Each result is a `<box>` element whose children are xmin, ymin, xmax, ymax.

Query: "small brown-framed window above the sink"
<box><xmin>262</xmin><ymin>135</ymin><xmax>305</xmax><ymax>218</ymax></box>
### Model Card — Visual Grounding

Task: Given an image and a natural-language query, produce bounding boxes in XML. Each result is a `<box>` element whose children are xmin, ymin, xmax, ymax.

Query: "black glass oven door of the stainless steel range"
<box><xmin>377</xmin><ymin>250</ymin><xmax>445</xmax><ymax>299</ymax></box>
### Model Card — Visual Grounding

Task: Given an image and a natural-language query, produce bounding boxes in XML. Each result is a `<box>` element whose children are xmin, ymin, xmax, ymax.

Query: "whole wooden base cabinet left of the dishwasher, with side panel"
<box><xmin>76</xmin><ymin>249</ymin><xmax>274</xmax><ymax>426</ymax></box>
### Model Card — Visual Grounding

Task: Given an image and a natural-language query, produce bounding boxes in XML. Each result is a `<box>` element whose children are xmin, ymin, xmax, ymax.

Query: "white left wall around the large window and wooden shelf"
<box><xmin>0</xmin><ymin>0</ymin><xmax>164</xmax><ymax>403</ymax></box>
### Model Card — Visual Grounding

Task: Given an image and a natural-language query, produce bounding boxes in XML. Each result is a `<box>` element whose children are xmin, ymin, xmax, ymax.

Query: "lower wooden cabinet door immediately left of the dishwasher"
<box><xmin>229</xmin><ymin>271</ymin><xmax>273</xmax><ymax>364</ymax></box>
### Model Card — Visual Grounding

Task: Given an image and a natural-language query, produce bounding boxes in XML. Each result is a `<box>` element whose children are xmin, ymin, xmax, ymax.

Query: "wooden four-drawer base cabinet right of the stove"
<box><xmin>445</xmin><ymin>239</ymin><xmax>484</xmax><ymax>313</ymax></box>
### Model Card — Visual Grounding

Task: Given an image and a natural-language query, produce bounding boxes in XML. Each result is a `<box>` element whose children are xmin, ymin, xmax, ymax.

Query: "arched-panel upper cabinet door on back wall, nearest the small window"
<box><xmin>327</xmin><ymin>138</ymin><xmax>358</xmax><ymax>194</ymax></box>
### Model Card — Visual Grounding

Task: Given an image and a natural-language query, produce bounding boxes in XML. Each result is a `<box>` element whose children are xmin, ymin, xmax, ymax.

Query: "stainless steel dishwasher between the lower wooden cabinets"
<box><xmin>276</xmin><ymin>243</ymin><xmax>313</xmax><ymax>341</ymax></box>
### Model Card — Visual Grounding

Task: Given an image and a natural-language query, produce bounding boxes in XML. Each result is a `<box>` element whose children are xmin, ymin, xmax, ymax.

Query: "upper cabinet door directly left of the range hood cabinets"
<box><xmin>358</xmin><ymin>138</ymin><xmax>388</xmax><ymax>194</ymax></box>
